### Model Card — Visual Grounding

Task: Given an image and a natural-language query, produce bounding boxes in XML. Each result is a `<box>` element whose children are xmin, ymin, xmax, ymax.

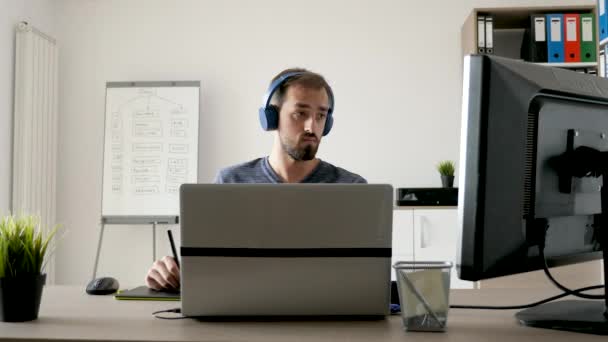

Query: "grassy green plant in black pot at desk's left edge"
<box><xmin>0</xmin><ymin>215</ymin><xmax>57</xmax><ymax>322</ymax></box>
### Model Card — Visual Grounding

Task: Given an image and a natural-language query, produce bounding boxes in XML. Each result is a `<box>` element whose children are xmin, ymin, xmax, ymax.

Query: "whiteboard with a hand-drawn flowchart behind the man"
<box><xmin>101</xmin><ymin>81</ymin><xmax>200</xmax><ymax>216</ymax></box>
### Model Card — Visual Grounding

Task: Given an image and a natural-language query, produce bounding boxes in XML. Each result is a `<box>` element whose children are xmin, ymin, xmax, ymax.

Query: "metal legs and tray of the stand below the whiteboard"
<box><xmin>91</xmin><ymin>216</ymin><xmax>179</xmax><ymax>279</ymax></box>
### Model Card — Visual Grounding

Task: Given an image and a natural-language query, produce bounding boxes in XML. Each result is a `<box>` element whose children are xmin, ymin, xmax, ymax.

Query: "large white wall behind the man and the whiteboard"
<box><xmin>56</xmin><ymin>0</ymin><xmax>595</xmax><ymax>285</ymax></box>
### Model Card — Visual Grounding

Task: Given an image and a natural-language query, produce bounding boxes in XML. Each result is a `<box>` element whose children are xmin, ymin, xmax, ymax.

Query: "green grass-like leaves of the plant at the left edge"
<box><xmin>0</xmin><ymin>215</ymin><xmax>58</xmax><ymax>278</ymax></box>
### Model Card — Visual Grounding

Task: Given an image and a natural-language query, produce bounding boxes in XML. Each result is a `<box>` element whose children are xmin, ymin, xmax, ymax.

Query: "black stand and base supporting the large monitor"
<box><xmin>515</xmin><ymin>162</ymin><xmax>608</xmax><ymax>335</ymax></box>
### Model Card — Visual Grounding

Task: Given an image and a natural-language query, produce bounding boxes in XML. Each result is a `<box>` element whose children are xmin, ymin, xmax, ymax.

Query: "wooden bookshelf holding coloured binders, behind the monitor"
<box><xmin>461</xmin><ymin>5</ymin><xmax>608</xmax><ymax>73</ymax></box>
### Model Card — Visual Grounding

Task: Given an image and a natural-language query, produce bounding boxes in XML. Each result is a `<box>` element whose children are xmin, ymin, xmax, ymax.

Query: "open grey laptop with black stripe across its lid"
<box><xmin>180</xmin><ymin>184</ymin><xmax>393</xmax><ymax>318</ymax></box>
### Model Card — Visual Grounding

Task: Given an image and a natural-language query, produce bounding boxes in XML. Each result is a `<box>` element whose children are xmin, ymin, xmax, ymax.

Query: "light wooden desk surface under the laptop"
<box><xmin>0</xmin><ymin>286</ymin><xmax>606</xmax><ymax>342</ymax></box>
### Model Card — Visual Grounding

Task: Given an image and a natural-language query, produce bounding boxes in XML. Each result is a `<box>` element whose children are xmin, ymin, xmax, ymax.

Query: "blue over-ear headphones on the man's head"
<box><xmin>259</xmin><ymin>72</ymin><xmax>334</xmax><ymax>136</ymax></box>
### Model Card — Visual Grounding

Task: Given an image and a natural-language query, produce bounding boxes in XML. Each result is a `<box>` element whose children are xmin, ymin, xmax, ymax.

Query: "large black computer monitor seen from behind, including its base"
<box><xmin>457</xmin><ymin>55</ymin><xmax>608</xmax><ymax>334</ymax></box>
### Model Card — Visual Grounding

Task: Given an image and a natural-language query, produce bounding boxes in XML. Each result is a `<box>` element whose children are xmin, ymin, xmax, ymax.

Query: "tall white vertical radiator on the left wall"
<box><xmin>12</xmin><ymin>22</ymin><xmax>58</xmax><ymax>283</ymax></box>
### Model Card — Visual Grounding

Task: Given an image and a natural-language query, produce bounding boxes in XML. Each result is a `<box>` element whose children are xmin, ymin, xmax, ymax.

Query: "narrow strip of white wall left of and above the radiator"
<box><xmin>0</xmin><ymin>0</ymin><xmax>54</xmax><ymax>214</ymax></box>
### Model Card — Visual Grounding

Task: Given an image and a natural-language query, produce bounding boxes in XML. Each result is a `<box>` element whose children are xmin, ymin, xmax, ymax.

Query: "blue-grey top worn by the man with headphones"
<box><xmin>215</xmin><ymin>157</ymin><xmax>367</xmax><ymax>184</ymax></box>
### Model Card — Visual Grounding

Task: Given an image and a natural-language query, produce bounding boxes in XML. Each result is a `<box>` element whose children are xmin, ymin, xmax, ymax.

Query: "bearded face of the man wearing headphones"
<box><xmin>279</xmin><ymin>84</ymin><xmax>329</xmax><ymax>161</ymax></box>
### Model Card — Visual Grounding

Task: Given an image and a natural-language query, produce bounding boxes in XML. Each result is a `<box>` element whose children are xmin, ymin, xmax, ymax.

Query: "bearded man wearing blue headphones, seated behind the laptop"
<box><xmin>146</xmin><ymin>69</ymin><xmax>367</xmax><ymax>290</ymax></box>
